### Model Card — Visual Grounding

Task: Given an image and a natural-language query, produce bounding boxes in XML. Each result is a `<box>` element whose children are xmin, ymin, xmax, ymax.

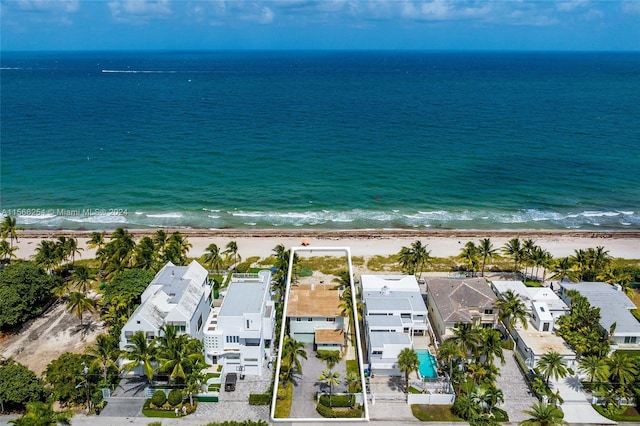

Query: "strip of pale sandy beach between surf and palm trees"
<box><xmin>11</xmin><ymin>229</ymin><xmax>640</xmax><ymax>259</ymax></box>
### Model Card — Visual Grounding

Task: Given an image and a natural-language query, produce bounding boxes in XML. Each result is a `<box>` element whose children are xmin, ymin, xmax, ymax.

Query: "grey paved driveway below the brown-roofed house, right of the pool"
<box><xmin>494</xmin><ymin>350</ymin><xmax>538</xmax><ymax>423</ymax></box>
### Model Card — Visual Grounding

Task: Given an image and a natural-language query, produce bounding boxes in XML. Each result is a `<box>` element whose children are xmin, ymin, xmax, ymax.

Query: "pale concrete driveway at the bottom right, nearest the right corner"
<box><xmin>550</xmin><ymin>375</ymin><xmax>618</xmax><ymax>425</ymax></box>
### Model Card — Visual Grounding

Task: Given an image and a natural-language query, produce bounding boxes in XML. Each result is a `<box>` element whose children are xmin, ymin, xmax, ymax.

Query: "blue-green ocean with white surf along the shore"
<box><xmin>0</xmin><ymin>51</ymin><xmax>640</xmax><ymax>230</ymax></box>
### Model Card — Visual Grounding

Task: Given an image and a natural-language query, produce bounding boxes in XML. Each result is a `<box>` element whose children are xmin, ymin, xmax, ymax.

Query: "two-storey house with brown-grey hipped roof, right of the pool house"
<box><xmin>426</xmin><ymin>278</ymin><xmax>498</xmax><ymax>342</ymax></box>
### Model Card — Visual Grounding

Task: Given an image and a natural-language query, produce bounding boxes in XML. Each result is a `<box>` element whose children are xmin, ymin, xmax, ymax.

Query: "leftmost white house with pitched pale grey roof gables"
<box><xmin>120</xmin><ymin>260</ymin><xmax>211</xmax><ymax>350</ymax></box>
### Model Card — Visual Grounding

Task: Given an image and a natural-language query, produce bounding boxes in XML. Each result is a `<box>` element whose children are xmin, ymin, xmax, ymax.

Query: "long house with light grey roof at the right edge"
<box><xmin>559</xmin><ymin>282</ymin><xmax>640</xmax><ymax>350</ymax></box>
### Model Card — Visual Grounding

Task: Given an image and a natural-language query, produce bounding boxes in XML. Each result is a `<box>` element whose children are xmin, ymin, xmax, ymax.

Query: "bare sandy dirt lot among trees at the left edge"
<box><xmin>0</xmin><ymin>302</ymin><xmax>104</xmax><ymax>375</ymax></box>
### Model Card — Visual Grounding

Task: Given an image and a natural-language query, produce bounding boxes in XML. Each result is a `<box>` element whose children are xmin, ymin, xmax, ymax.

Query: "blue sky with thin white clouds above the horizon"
<box><xmin>0</xmin><ymin>0</ymin><xmax>640</xmax><ymax>51</ymax></box>
